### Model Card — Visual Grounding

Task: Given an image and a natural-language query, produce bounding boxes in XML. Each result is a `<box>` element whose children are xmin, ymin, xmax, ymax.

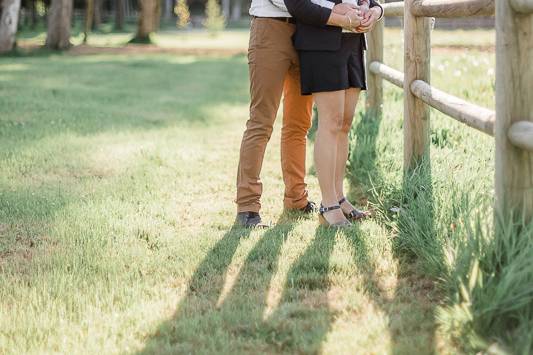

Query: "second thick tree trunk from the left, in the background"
<box><xmin>46</xmin><ymin>0</ymin><xmax>72</xmax><ymax>49</ymax></box>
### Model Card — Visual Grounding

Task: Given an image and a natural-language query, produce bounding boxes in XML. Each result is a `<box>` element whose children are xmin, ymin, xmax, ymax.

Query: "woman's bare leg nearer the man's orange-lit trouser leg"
<box><xmin>313</xmin><ymin>90</ymin><xmax>346</xmax><ymax>224</ymax></box>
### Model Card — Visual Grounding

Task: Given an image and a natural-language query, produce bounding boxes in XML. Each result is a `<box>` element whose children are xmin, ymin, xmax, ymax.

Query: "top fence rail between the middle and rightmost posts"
<box><xmin>413</xmin><ymin>0</ymin><xmax>494</xmax><ymax>18</ymax></box>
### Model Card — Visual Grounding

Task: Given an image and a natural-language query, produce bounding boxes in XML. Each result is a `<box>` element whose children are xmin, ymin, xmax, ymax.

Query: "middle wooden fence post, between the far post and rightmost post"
<box><xmin>403</xmin><ymin>0</ymin><xmax>431</xmax><ymax>170</ymax></box>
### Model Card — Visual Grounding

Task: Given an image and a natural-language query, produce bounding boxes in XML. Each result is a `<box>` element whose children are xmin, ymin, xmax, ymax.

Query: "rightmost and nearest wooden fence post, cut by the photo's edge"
<box><xmin>495</xmin><ymin>0</ymin><xmax>533</xmax><ymax>221</ymax></box>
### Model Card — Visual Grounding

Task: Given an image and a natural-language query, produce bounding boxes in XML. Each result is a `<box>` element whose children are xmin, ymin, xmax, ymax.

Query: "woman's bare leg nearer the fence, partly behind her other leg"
<box><xmin>335</xmin><ymin>88</ymin><xmax>361</xmax><ymax>213</ymax></box>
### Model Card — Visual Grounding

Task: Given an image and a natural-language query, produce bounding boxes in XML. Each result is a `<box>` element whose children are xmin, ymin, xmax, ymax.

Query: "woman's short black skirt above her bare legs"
<box><xmin>299</xmin><ymin>33</ymin><xmax>366</xmax><ymax>95</ymax></box>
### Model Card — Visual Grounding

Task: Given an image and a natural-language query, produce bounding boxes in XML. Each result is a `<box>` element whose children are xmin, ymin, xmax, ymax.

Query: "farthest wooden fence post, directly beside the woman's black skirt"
<box><xmin>366</xmin><ymin>18</ymin><xmax>385</xmax><ymax>117</ymax></box>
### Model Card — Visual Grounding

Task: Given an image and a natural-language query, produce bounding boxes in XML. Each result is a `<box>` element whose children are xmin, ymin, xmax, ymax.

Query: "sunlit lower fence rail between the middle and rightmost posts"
<box><xmin>411</xmin><ymin>80</ymin><xmax>495</xmax><ymax>136</ymax></box>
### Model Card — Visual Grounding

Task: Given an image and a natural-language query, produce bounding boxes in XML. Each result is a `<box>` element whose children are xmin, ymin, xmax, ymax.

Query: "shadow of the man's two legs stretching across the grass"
<box><xmin>140</xmin><ymin>214</ymin><xmax>302</xmax><ymax>354</ymax></box>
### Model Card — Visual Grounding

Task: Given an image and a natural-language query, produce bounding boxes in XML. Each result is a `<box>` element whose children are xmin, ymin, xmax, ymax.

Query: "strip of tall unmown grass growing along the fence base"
<box><xmin>348</xmin><ymin>105</ymin><xmax>533</xmax><ymax>354</ymax></box>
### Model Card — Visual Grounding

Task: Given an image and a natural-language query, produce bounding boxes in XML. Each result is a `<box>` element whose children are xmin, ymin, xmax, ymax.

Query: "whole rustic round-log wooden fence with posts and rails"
<box><xmin>366</xmin><ymin>0</ymin><xmax>533</xmax><ymax>225</ymax></box>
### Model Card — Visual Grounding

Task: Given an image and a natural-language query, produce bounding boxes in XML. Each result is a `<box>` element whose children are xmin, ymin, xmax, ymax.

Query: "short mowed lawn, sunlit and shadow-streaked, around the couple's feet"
<box><xmin>0</xmin><ymin>28</ymin><xmax>494</xmax><ymax>354</ymax></box>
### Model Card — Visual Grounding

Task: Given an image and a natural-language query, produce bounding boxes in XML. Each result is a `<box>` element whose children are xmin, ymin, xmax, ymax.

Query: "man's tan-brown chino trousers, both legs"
<box><xmin>236</xmin><ymin>18</ymin><xmax>313</xmax><ymax>212</ymax></box>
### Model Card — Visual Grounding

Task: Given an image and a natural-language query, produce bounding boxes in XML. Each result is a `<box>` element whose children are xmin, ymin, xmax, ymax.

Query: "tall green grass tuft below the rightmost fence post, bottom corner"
<box><xmin>439</xmin><ymin>213</ymin><xmax>533</xmax><ymax>354</ymax></box>
